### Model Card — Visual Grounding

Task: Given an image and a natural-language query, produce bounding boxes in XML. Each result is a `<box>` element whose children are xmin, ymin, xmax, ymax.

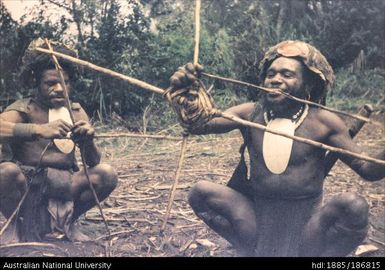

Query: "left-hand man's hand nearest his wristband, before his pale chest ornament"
<box><xmin>34</xmin><ymin>119</ymin><xmax>72</xmax><ymax>139</ymax></box>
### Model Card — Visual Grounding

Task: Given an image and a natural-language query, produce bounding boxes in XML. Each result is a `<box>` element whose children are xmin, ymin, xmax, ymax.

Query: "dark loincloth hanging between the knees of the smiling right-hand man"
<box><xmin>254</xmin><ymin>195</ymin><xmax>322</xmax><ymax>257</ymax></box>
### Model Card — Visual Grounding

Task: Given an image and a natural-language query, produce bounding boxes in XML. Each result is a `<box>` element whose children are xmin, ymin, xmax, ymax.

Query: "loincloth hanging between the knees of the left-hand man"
<box><xmin>11</xmin><ymin>165</ymin><xmax>74</xmax><ymax>241</ymax></box>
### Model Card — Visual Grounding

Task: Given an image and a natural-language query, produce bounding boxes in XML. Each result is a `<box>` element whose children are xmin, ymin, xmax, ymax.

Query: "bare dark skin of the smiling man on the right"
<box><xmin>170</xmin><ymin>56</ymin><xmax>385</xmax><ymax>256</ymax></box>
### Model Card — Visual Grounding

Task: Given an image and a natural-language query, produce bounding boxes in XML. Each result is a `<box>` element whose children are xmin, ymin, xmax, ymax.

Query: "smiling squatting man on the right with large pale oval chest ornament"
<box><xmin>170</xmin><ymin>41</ymin><xmax>385</xmax><ymax>257</ymax></box>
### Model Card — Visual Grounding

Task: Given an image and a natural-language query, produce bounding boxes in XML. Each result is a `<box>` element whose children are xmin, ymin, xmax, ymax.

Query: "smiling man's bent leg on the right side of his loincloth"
<box><xmin>300</xmin><ymin>193</ymin><xmax>369</xmax><ymax>257</ymax></box>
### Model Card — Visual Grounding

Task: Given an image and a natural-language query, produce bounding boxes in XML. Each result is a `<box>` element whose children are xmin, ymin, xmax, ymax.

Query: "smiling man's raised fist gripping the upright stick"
<box><xmin>170</xmin><ymin>63</ymin><xmax>203</xmax><ymax>89</ymax></box>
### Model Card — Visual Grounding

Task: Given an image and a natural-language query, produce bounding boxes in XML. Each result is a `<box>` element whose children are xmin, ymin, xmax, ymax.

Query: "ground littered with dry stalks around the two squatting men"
<box><xmin>0</xmin><ymin>112</ymin><xmax>385</xmax><ymax>257</ymax></box>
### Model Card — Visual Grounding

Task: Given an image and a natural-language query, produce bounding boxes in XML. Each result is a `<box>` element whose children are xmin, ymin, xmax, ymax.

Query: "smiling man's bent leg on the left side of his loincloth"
<box><xmin>189</xmin><ymin>181</ymin><xmax>257</xmax><ymax>256</ymax></box>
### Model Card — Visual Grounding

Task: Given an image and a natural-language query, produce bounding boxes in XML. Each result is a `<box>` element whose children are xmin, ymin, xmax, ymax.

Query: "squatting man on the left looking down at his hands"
<box><xmin>0</xmin><ymin>39</ymin><xmax>117</xmax><ymax>243</ymax></box>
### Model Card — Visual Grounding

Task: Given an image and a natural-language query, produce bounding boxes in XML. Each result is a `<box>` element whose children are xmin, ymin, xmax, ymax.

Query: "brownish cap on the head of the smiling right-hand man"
<box><xmin>259</xmin><ymin>40</ymin><xmax>335</xmax><ymax>102</ymax></box>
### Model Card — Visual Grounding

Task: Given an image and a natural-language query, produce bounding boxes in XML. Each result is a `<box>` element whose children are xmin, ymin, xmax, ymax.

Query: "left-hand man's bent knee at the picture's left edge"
<box><xmin>0</xmin><ymin>162</ymin><xmax>26</xmax><ymax>188</ymax></box>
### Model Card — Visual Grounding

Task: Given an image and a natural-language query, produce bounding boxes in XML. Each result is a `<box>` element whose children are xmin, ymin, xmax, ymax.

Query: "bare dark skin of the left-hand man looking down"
<box><xmin>0</xmin><ymin>67</ymin><xmax>117</xmax><ymax>241</ymax></box>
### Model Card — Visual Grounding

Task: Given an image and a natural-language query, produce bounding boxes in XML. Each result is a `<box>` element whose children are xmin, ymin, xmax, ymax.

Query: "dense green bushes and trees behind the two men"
<box><xmin>0</xmin><ymin>0</ymin><xmax>385</xmax><ymax>130</ymax></box>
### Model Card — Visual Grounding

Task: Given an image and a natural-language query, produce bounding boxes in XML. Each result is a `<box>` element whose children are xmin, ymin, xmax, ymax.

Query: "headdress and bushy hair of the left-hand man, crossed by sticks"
<box><xmin>19</xmin><ymin>38</ymin><xmax>79</xmax><ymax>87</ymax></box>
